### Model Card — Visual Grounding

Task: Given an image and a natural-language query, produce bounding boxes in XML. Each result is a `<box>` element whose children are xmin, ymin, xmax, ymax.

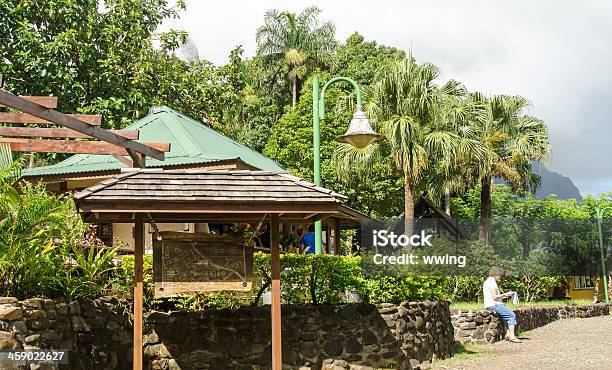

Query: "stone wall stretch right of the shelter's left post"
<box><xmin>144</xmin><ymin>302</ymin><xmax>454</xmax><ymax>369</ymax></box>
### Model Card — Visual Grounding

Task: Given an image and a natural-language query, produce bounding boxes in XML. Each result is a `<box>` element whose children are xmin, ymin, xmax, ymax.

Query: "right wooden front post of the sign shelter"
<box><xmin>270</xmin><ymin>213</ymin><xmax>283</xmax><ymax>370</ymax></box>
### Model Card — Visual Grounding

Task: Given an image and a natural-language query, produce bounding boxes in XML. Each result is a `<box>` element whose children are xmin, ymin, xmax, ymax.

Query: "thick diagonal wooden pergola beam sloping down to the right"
<box><xmin>0</xmin><ymin>90</ymin><xmax>170</xmax><ymax>161</ymax></box>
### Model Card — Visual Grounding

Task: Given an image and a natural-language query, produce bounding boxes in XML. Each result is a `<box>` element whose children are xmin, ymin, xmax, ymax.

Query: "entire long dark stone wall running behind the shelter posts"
<box><xmin>0</xmin><ymin>298</ymin><xmax>454</xmax><ymax>369</ymax></box>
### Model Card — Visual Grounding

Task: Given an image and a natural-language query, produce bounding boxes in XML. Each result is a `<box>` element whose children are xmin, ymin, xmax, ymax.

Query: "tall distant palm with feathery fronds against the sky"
<box><xmin>256</xmin><ymin>6</ymin><xmax>337</xmax><ymax>109</ymax></box>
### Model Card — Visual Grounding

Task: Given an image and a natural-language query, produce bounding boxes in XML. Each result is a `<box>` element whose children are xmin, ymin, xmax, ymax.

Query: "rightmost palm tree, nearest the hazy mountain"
<box><xmin>469</xmin><ymin>93</ymin><xmax>550</xmax><ymax>244</ymax></box>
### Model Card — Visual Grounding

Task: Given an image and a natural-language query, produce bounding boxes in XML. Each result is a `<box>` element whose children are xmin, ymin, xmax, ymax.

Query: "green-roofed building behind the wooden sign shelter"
<box><xmin>21</xmin><ymin>106</ymin><xmax>365</xmax><ymax>253</ymax></box>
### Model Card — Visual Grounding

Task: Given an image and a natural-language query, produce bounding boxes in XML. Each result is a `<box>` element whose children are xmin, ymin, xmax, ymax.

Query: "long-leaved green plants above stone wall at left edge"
<box><xmin>0</xmin><ymin>162</ymin><xmax>116</xmax><ymax>299</ymax></box>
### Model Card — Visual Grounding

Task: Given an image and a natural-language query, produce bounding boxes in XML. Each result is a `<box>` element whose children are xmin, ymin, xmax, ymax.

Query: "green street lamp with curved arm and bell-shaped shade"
<box><xmin>312</xmin><ymin>76</ymin><xmax>380</xmax><ymax>254</ymax></box>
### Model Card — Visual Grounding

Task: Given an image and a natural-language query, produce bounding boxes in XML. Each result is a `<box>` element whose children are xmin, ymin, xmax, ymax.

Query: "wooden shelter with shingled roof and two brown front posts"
<box><xmin>74</xmin><ymin>169</ymin><xmax>364</xmax><ymax>370</ymax></box>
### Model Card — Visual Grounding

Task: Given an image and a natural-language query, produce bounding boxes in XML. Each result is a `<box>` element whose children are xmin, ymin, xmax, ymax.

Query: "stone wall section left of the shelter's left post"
<box><xmin>0</xmin><ymin>297</ymin><xmax>132</xmax><ymax>369</ymax></box>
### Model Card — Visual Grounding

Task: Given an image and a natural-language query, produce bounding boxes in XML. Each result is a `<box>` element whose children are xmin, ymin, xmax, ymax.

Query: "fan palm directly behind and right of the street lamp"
<box><xmin>334</xmin><ymin>55</ymin><xmax>467</xmax><ymax>234</ymax></box>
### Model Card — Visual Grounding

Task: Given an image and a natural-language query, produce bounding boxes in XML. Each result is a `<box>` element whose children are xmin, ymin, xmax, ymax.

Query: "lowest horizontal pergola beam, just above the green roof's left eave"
<box><xmin>0</xmin><ymin>139</ymin><xmax>170</xmax><ymax>155</ymax></box>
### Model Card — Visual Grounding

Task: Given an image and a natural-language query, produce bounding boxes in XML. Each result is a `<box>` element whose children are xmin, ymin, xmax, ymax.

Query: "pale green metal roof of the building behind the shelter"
<box><xmin>23</xmin><ymin>106</ymin><xmax>286</xmax><ymax>177</ymax></box>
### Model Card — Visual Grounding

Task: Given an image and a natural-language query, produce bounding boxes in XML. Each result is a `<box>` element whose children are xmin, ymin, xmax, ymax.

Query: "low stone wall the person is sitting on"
<box><xmin>451</xmin><ymin>304</ymin><xmax>610</xmax><ymax>343</ymax></box>
